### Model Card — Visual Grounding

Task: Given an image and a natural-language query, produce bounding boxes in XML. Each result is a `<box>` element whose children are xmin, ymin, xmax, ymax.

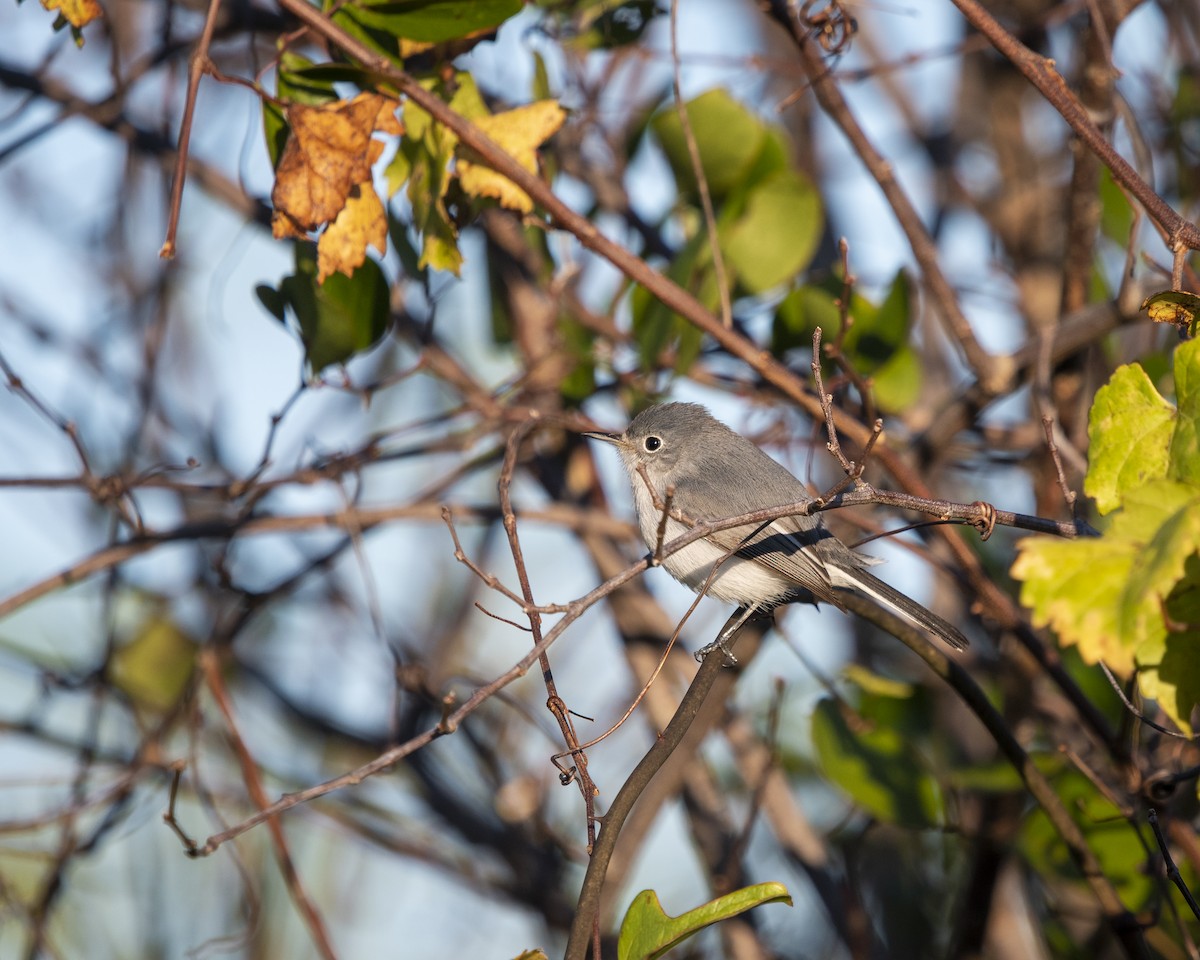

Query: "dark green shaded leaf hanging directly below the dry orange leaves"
<box><xmin>259</xmin><ymin>244</ymin><xmax>391</xmax><ymax>373</ymax></box>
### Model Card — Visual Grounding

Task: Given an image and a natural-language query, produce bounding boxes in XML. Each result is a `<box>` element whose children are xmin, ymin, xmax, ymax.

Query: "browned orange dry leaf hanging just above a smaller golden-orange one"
<box><xmin>271</xmin><ymin>94</ymin><xmax>388</xmax><ymax>239</ymax></box>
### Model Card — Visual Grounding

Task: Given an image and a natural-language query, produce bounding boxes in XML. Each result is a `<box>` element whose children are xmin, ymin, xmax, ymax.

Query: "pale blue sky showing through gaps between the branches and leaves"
<box><xmin>0</xmin><ymin>0</ymin><xmax>1170</xmax><ymax>958</ymax></box>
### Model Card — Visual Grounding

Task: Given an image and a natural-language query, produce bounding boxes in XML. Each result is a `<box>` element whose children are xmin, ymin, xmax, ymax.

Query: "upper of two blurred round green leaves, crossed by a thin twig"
<box><xmin>650</xmin><ymin>89</ymin><xmax>767</xmax><ymax>200</ymax></box>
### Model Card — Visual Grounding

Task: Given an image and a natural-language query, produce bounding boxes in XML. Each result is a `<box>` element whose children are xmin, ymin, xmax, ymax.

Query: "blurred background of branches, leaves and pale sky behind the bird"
<box><xmin>0</xmin><ymin>0</ymin><xmax>1200</xmax><ymax>959</ymax></box>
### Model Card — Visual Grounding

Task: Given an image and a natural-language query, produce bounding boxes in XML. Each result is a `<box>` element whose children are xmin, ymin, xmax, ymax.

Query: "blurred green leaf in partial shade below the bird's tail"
<box><xmin>812</xmin><ymin>700</ymin><xmax>943</xmax><ymax>827</ymax></box>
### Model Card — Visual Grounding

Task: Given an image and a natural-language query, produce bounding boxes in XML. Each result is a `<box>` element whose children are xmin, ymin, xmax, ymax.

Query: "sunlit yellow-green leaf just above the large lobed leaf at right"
<box><xmin>1084</xmin><ymin>364</ymin><xmax>1175</xmax><ymax>514</ymax></box>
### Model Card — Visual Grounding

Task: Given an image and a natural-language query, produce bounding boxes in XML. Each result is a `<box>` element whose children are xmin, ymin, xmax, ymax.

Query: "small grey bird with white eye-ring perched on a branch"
<box><xmin>586</xmin><ymin>403</ymin><xmax>967</xmax><ymax>650</ymax></box>
